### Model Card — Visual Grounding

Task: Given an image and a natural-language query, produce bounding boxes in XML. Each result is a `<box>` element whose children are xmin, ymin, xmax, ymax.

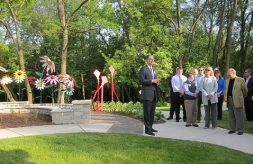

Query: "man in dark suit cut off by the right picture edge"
<box><xmin>244</xmin><ymin>69</ymin><xmax>253</xmax><ymax>121</ymax></box>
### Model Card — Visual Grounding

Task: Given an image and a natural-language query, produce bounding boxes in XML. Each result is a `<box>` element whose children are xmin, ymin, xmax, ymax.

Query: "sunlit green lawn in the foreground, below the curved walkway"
<box><xmin>0</xmin><ymin>133</ymin><xmax>253</xmax><ymax>164</ymax></box>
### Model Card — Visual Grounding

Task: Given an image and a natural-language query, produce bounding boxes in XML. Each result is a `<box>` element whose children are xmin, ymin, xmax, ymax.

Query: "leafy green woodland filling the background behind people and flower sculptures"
<box><xmin>0</xmin><ymin>0</ymin><xmax>253</xmax><ymax>102</ymax></box>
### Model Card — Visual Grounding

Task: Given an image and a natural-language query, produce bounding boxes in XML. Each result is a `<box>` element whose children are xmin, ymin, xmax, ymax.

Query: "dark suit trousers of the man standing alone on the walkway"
<box><xmin>143</xmin><ymin>98</ymin><xmax>156</xmax><ymax>131</ymax></box>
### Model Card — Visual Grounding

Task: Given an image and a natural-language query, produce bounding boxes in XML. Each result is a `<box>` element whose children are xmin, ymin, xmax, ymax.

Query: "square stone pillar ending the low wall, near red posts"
<box><xmin>72</xmin><ymin>100</ymin><xmax>91</xmax><ymax>124</ymax></box>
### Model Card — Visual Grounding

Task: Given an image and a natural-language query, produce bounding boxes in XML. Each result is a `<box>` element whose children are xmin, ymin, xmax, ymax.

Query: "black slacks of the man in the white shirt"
<box><xmin>170</xmin><ymin>92</ymin><xmax>186</xmax><ymax>121</ymax></box>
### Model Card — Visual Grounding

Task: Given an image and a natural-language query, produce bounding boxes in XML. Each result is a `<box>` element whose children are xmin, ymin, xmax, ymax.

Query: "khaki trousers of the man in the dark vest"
<box><xmin>184</xmin><ymin>99</ymin><xmax>198</xmax><ymax>124</ymax></box>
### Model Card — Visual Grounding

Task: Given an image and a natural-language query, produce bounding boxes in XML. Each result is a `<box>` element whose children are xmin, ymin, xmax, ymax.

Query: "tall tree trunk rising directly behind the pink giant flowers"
<box><xmin>57</xmin><ymin>0</ymin><xmax>68</xmax><ymax>104</ymax></box>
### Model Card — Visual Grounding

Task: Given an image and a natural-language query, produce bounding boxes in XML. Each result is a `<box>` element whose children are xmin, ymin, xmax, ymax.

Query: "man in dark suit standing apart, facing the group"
<box><xmin>139</xmin><ymin>55</ymin><xmax>160</xmax><ymax>135</ymax></box>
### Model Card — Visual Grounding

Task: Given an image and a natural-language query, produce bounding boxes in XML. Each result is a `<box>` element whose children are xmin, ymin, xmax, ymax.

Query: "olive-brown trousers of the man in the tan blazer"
<box><xmin>228</xmin><ymin>97</ymin><xmax>244</xmax><ymax>132</ymax></box>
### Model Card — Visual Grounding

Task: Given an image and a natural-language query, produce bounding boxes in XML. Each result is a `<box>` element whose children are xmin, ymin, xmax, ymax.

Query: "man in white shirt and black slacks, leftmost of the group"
<box><xmin>171</xmin><ymin>67</ymin><xmax>187</xmax><ymax>122</ymax></box>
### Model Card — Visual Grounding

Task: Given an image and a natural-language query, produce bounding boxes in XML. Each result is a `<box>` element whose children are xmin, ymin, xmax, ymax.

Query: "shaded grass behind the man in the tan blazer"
<box><xmin>218</xmin><ymin>110</ymin><xmax>253</xmax><ymax>134</ymax></box>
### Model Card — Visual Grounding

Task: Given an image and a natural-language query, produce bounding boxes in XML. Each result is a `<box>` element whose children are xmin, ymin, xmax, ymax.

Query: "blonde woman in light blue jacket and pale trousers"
<box><xmin>200</xmin><ymin>67</ymin><xmax>218</xmax><ymax>128</ymax></box>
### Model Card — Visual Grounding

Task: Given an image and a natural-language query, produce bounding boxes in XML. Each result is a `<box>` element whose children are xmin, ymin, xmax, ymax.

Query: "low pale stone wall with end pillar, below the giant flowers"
<box><xmin>0</xmin><ymin>100</ymin><xmax>91</xmax><ymax>124</ymax></box>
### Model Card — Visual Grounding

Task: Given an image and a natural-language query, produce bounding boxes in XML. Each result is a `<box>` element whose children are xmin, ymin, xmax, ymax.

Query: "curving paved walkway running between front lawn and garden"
<box><xmin>0</xmin><ymin>112</ymin><xmax>253</xmax><ymax>154</ymax></box>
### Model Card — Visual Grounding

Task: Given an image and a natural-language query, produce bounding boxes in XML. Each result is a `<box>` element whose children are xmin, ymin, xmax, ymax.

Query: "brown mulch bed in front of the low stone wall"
<box><xmin>0</xmin><ymin>113</ymin><xmax>53</xmax><ymax>129</ymax></box>
